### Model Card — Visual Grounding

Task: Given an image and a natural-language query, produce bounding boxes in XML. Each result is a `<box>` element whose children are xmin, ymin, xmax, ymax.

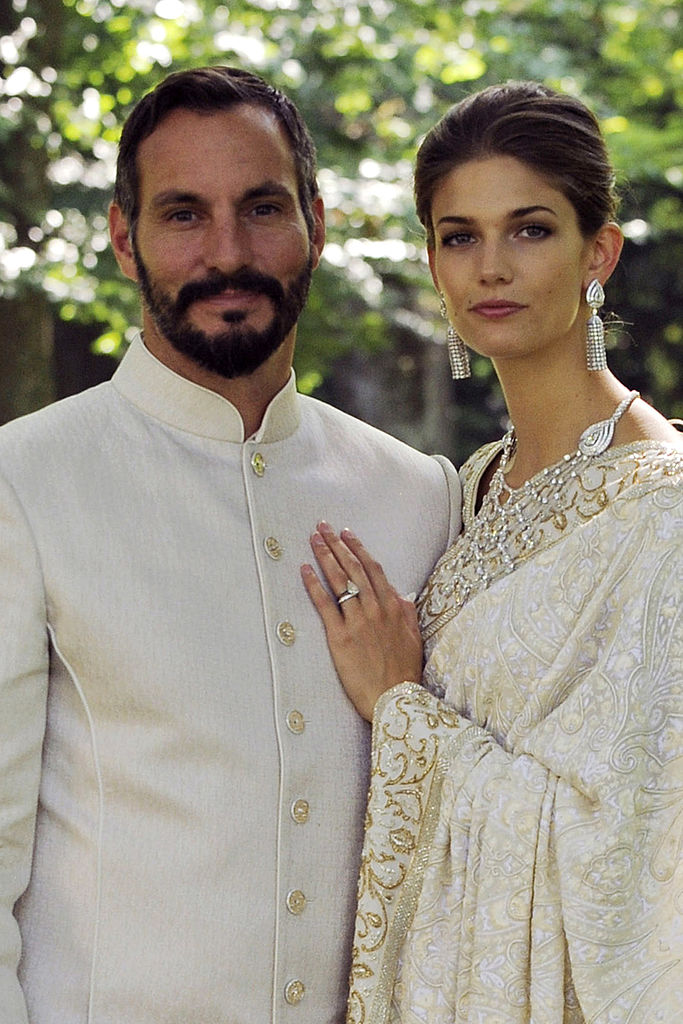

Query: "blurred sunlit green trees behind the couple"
<box><xmin>0</xmin><ymin>0</ymin><xmax>683</xmax><ymax>463</ymax></box>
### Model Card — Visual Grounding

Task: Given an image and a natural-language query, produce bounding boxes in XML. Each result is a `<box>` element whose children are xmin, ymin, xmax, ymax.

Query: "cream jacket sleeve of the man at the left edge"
<box><xmin>0</xmin><ymin>478</ymin><xmax>48</xmax><ymax>1024</ymax></box>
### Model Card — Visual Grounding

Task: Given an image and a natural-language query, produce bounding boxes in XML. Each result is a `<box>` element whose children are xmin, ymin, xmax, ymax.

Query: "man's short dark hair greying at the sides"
<box><xmin>114</xmin><ymin>67</ymin><xmax>318</xmax><ymax>236</ymax></box>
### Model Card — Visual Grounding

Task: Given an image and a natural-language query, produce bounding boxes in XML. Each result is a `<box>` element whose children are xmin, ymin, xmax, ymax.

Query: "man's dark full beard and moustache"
<box><xmin>133</xmin><ymin>246</ymin><xmax>313</xmax><ymax>378</ymax></box>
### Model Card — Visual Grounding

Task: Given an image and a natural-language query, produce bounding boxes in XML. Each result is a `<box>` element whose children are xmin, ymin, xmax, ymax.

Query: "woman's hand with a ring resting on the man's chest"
<box><xmin>301</xmin><ymin>522</ymin><xmax>422</xmax><ymax>722</ymax></box>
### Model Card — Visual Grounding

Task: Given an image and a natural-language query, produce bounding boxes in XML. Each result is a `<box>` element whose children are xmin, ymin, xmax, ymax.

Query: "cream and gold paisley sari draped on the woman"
<box><xmin>347</xmin><ymin>443</ymin><xmax>683</xmax><ymax>1024</ymax></box>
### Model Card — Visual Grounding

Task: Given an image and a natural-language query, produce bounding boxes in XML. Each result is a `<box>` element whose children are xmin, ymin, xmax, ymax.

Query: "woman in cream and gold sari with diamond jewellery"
<box><xmin>302</xmin><ymin>83</ymin><xmax>683</xmax><ymax>1024</ymax></box>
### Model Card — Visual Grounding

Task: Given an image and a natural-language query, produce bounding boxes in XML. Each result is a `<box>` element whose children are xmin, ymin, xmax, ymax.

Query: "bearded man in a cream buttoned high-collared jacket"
<box><xmin>0</xmin><ymin>68</ymin><xmax>460</xmax><ymax>1024</ymax></box>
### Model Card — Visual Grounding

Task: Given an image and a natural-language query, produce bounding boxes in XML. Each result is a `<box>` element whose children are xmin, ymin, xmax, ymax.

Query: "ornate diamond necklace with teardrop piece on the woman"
<box><xmin>467</xmin><ymin>391</ymin><xmax>639</xmax><ymax>587</ymax></box>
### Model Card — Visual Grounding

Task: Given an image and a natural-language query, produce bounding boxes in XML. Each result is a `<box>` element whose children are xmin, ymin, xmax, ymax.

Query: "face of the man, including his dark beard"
<box><xmin>114</xmin><ymin>104</ymin><xmax>322</xmax><ymax>378</ymax></box>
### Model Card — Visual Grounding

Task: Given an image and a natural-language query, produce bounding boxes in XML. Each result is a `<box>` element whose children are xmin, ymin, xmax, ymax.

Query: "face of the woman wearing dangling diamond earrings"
<box><xmin>429</xmin><ymin>157</ymin><xmax>604</xmax><ymax>370</ymax></box>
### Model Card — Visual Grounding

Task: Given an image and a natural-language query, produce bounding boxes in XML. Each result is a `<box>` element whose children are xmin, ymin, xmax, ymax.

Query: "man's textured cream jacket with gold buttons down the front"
<box><xmin>0</xmin><ymin>340</ymin><xmax>460</xmax><ymax>1024</ymax></box>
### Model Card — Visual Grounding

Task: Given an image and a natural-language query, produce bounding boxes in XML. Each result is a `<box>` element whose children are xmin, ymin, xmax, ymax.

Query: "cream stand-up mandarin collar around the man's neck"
<box><xmin>112</xmin><ymin>332</ymin><xmax>300</xmax><ymax>444</ymax></box>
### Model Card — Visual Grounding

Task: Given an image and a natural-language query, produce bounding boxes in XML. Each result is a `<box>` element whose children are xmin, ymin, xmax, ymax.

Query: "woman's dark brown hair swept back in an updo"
<box><xmin>415</xmin><ymin>82</ymin><xmax>618</xmax><ymax>247</ymax></box>
